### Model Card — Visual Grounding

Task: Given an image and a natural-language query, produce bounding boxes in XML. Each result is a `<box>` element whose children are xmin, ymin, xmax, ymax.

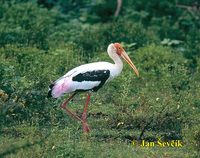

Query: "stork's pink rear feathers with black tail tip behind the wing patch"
<box><xmin>48</xmin><ymin>78</ymin><xmax>70</xmax><ymax>98</ymax></box>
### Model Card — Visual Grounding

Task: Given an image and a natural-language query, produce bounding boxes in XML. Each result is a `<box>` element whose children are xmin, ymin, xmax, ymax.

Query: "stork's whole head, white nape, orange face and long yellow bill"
<box><xmin>108</xmin><ymin>43</ymin><xmax>139</xmax><ymax>76</ymax></box>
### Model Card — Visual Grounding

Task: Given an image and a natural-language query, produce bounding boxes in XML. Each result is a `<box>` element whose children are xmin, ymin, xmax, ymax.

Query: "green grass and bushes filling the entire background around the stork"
<box><xmin>0</xmin><ymin>0</ymin><xmax>200</xmax><ymax>158</ymax></box>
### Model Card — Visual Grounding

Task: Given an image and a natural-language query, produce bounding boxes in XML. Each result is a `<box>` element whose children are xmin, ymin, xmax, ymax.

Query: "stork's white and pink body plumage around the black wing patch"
<box><xmin>51</xmin><ymin>59</ymin><xmax>123</xmax><ymax>98</ymax></box>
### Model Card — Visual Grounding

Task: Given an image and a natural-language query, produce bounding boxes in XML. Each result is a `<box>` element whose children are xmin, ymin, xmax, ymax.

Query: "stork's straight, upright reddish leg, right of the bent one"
<box><xmin>82</xmin><ymin>93</ymin><xmax>90</xmax><ymax>133</ymax></box>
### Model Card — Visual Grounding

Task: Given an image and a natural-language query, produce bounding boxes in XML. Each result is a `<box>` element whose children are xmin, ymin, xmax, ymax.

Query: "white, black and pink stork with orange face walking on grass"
<box><xmin>48</xmin><ymin>43</ymin><xmax>139</xmax><ymax>133</ymax></box>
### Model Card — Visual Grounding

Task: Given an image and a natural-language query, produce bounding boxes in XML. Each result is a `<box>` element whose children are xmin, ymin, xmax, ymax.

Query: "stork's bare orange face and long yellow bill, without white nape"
<box><xmin>114</xmin><ymin>43</ymin><xmax>139</xmax><ymax>76</ymax></box>
